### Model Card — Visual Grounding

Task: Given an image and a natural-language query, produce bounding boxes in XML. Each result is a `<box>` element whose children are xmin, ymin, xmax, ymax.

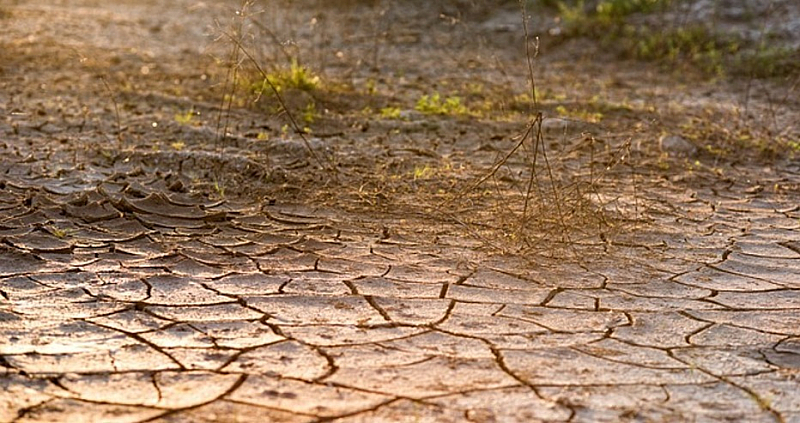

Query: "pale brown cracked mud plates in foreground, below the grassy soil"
<box><xmin>0</xmin><ymin>0</ymin><xmax>800</xmax><ymax>423</ymax></box>
